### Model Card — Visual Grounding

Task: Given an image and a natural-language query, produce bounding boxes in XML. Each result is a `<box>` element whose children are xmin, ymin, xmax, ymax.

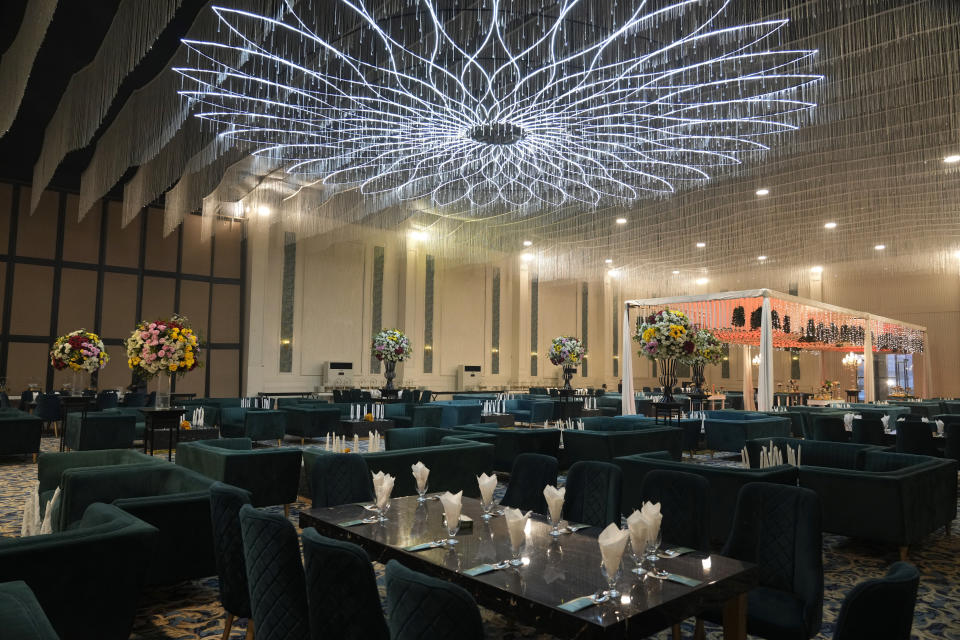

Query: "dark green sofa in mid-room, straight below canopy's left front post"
<box><xmin>560</xmin><ymin>426</ymin><xmax>683</xmax><ymax>469</ymax></box>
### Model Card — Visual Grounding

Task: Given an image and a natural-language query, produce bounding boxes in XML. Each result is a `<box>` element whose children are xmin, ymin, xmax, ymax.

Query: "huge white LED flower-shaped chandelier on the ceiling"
<box><xmin>176</xmin><ymin>0</ymin><xmax>820</xmax><ymax>212</ymax></box>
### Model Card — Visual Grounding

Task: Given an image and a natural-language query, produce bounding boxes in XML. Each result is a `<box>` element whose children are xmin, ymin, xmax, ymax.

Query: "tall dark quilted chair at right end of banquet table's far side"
<box><xmin>721</xmin><ymin>482</ymin><xmax>823</xmax><ymax>637</ymax></box>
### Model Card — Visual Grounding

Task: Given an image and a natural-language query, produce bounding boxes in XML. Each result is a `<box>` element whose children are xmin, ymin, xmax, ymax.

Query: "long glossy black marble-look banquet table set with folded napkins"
<box><xmin>300</xmin><ymin>496</ymin><xmax>758</xmax><ymax>639</ymax></box>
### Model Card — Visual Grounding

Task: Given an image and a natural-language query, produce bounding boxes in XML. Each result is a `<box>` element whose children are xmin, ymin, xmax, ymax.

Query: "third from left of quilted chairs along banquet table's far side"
<box><xmin>563</xmin><ymin>460</ymin><xmax>623</xmax><ymax>527</ymax></box>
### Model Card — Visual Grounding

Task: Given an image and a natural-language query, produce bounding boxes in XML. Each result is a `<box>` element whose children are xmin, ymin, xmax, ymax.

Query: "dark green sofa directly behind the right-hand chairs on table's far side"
<box><xmin>613</xmin><ymin>451</ymin><xmax>797</xmax><ymax>547</ymax></box>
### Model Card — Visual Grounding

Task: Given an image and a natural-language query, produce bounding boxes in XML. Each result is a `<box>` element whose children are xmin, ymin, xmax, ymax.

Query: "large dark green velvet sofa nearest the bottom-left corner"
<box><xmin>0</xmin><ymin>502</ymin><xmax>159</xmax><ymax>640</ymax></box>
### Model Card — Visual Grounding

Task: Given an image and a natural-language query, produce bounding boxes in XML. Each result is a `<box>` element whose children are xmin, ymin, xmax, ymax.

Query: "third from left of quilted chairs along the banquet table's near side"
<box><xmin>301</xmin><ymin>527</ymin><xmax>390</xmax><ymax>640</ymax></box>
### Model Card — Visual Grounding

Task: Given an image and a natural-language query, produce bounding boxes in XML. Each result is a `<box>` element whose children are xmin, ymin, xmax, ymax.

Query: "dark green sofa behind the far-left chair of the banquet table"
<box><xmin>303</xmin><ymin>430</ymin><xmax>494</xmax><ymax>497</ymax></box>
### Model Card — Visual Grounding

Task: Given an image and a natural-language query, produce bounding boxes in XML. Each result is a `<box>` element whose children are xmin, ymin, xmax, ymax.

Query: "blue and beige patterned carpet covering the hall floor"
<box><xmin>0</xmin><ymin>438</ymin><xmax>960</xmax><ymax>640</ymax></box>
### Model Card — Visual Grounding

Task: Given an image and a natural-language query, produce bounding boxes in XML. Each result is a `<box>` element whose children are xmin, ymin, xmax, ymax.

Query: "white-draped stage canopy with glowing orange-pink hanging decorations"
<box><xmin>621</xmin><ymin>289</ymin><xmax>927</xmax><ymax>413</ymax></box>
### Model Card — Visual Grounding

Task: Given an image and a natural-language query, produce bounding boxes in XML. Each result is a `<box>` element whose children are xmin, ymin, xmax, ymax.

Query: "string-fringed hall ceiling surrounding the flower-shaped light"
<box><xmin>0</xmin><ymin>0</ymin><xmax>960</xmax><ymax>281</ymax></box>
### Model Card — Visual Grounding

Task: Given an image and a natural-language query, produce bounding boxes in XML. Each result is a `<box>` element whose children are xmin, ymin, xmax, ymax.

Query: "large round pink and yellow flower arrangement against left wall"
<box><xmin>127</xmin><ymin>314</ymin><xmax>200</xmax><ymax>379</ymax></box>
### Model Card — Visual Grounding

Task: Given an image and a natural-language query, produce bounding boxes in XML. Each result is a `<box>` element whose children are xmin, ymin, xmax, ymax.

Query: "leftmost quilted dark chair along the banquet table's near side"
<box><xmin>210</xmin><ymin>482</ymin><xmax>251</xmax><ymax>618</ymax></box>
